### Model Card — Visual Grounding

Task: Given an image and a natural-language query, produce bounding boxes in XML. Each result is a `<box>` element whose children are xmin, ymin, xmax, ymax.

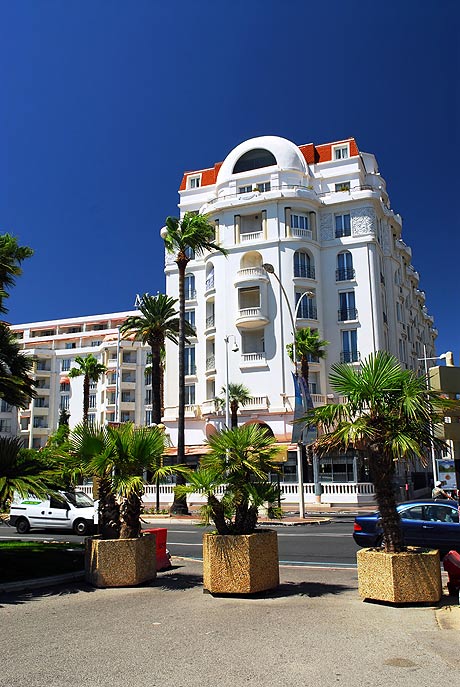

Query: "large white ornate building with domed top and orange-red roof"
<box><xmin>164</xmin><ymin>136</ymin><xmax>437</xmax><ymax>490</ymax></box>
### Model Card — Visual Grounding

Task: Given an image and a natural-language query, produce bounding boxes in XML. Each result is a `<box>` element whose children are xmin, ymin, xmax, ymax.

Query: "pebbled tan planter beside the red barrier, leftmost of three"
<box><xmin>85</xmin><ymin>534</ymin><xmax>156</xmax><ymax>587</ymax></box>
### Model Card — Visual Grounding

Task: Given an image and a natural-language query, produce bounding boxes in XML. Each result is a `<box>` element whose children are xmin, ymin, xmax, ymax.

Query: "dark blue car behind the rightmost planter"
<box><xmin>353</xmin><ymin>499</ymin><xmax>460</xmax><ymax>555</ymax></box>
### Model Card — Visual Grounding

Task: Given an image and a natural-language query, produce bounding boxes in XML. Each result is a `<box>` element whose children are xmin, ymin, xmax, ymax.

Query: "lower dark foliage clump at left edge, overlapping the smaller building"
<box><xmin>0</xmin><ymin>322</ymin><xmax>35</xmax><ymax>408</ymax></box>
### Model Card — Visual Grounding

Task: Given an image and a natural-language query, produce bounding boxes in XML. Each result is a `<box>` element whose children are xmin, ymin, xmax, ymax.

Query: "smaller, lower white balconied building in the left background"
<box><xmin>4</xmin><ymin>311</ymin><xmax>152</xmax><ymax>449</ymax></box>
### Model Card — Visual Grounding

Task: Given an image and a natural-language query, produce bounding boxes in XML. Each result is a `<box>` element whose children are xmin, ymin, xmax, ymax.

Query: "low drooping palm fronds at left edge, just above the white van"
<box><xmin>0</xmin><ymin>437</ymin><xmax>50</xmax><ymax>511</ymax></box>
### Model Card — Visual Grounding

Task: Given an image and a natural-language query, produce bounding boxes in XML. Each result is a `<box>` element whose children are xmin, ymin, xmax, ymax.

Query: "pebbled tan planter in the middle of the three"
<box><xmin>203</xmin><ymin>530</ymin><xmax>279</xmax><ymax>594</ymax></box>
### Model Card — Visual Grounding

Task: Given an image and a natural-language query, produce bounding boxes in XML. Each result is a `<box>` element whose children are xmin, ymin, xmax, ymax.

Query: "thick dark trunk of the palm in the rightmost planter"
<box><xmin>369</xmin><ymin>452</ymin><xmax>405</xmax><ymax>553</ymax></box>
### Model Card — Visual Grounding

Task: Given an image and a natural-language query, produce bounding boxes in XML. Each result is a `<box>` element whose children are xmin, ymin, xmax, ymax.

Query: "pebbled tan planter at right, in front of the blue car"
<box><xmin>357</xmin><ymin>547</ymin><xmax>442</xmax><ymax>603</ymax></box>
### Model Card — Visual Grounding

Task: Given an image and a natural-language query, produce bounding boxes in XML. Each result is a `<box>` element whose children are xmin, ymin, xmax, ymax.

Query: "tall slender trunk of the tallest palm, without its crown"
<box><xmin>170</xmin><ymin>253</ymin><xmax>189</xmax><ymax>515</ymax></box>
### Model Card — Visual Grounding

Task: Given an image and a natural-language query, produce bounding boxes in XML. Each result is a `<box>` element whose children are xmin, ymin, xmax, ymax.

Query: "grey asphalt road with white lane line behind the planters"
<box><xmin>0</xmin><ymin>518</ymin><xmax>358</xmax><ymax>568</ymax></box>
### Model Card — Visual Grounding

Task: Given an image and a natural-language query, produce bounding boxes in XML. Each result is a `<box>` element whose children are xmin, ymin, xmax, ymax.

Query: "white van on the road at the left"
<box><xmin>9</xmin><ymin>491</ymin><xmax>94</xmax><ymax>535</ymax></box>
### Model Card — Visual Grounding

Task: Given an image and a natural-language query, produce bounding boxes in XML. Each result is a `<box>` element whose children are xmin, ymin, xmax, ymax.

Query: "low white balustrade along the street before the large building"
<box><xmin>78</xmin><ymin>482</ymin><xmax>375</xmax><ymax>508</ymax></box>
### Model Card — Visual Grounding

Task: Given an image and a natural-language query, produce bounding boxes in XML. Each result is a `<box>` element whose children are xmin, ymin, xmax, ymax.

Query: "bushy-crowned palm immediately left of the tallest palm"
<box><xmin>120</xmin><ymin>293</ymin><xmax>195</xmax><ymax>424</ymax></box>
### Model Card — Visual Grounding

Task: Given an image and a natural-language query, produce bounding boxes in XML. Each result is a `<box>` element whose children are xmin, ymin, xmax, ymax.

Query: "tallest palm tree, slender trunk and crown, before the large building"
<box><xmin>161</xmin><ymin>212</ymin><xmax>227</xmax><ymax>513</ymax></box>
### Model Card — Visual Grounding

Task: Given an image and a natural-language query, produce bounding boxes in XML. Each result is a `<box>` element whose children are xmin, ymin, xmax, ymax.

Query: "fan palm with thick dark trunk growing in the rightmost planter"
<box><xmin>306</xmin><ymin>351</ymin><xmax>459</xmax><ymax>553</ymax></box>
